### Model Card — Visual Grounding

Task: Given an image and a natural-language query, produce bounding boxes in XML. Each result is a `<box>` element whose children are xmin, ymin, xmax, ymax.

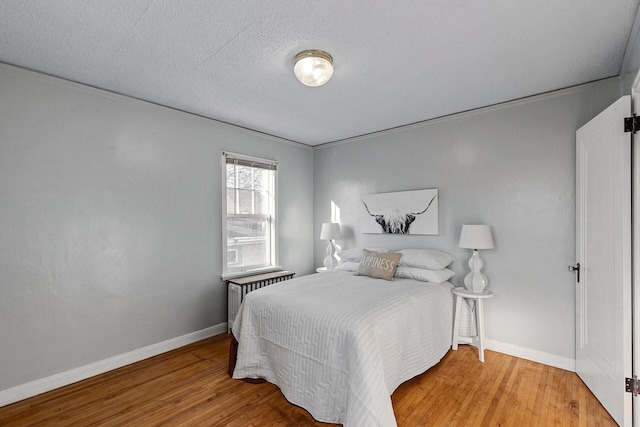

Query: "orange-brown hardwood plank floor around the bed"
<box><xmin>0</xmin><ymin>334</ymin><xmax>616</xmax><ymax>427</ymax></box>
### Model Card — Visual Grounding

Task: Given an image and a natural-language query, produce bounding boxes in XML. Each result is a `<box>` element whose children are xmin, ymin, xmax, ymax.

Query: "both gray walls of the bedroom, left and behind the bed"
<box><xmin>0</xmin><ymin>59</ymin><xmax>631</xmax><ymax>390</ymax></box>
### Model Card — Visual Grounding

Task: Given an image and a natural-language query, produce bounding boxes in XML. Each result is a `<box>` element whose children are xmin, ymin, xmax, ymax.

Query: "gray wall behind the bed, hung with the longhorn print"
<box><xmin>314</xmin><ymin>78</ymin><xmax>623</xmax><ymax>359</ymax></box>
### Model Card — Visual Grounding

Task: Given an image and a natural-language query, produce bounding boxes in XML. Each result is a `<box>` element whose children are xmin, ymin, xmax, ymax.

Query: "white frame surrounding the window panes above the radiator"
<box><xmin>220</xmin><ymin>151</ymin><xmax>282</xmax><ymax>279</ymax></box>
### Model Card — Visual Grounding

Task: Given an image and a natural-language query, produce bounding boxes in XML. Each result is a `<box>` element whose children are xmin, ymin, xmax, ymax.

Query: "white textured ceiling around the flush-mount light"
<box><xmin>0</xmin><ymin>0</ymin><xmax>640</xmax><ymax>145</ymax></box>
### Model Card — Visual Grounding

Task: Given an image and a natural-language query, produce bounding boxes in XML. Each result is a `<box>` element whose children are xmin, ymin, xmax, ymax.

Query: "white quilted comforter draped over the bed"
<box><xmin>233</xmin><ymin>272</ymin><xmax>453</xmax><ymax>427</ymax></box>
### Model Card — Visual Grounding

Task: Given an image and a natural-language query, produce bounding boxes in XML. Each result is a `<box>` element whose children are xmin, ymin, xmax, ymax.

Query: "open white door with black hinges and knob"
<box><xmin>576</xmin><ymin>96</ymin><xmax>632</xmax><ymax>426</ymax></box>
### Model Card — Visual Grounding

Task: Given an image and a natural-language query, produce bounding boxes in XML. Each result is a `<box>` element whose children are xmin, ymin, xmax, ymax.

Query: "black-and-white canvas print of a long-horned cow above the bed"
<box><xmin>360</xmin><ymin>189</ymin><xmax>438</xmax><ymax>234</ymax></box>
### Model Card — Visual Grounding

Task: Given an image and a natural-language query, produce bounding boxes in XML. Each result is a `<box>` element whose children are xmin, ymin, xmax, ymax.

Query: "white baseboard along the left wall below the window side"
<box><xmin>0</xmin><ymin>323</ymin><xmax>227</xmax><ymax>407</ymax></box>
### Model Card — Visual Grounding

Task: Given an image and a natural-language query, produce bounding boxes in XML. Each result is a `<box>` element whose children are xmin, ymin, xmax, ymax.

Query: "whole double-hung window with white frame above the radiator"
<box><xmin>222</xmin><ymin>152</ymin><xmax>279</xmax><ymax>278</ymax></box>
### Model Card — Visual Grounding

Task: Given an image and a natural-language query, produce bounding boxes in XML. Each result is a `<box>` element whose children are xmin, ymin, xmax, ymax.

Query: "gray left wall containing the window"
<box><xmin>0</xmin><ymin>65</ymin><xmax>313</xmax><ymax>390</ymax></box>
